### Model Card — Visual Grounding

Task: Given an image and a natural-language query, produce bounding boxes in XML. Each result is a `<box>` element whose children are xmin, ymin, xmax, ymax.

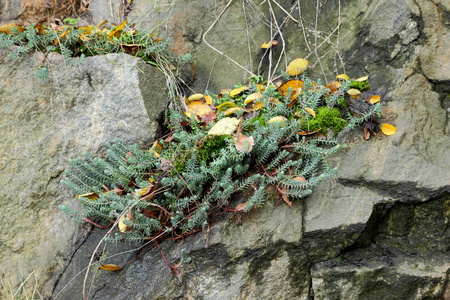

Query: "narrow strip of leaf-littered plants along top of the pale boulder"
<box><xmin>0</xmin><ymin>19</ymin><xmax>191</xmax><ymax>109</ymax></box>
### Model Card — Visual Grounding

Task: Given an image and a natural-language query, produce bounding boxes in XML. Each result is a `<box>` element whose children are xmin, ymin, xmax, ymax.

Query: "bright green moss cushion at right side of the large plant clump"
<box><xmin>302</xmin><ymin>106</ymin><xmax>347</xmax><ymax>135</ymax></box>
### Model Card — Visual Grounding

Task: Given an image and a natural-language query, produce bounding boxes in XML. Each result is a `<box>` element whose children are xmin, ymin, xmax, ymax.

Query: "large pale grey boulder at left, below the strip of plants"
<box><xmin>0</xmin><ymin>52</ymin><xmax>167</xmax><ymax>295</ymax></box>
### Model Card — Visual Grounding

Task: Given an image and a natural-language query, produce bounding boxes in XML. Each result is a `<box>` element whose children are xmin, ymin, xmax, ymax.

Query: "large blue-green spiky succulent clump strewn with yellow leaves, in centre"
<box><xmin>61</xmin><ymin>58</ymin><xmax>396</xmax><ymax>246</ymax></box>
